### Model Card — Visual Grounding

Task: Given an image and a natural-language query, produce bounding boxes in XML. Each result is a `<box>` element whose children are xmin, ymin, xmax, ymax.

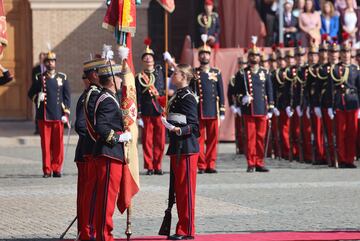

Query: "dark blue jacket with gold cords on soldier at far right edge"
<box><xmin>330</xmin><ymin>64</ymin><xmax>360</xmax><ymax>110</ymax></box>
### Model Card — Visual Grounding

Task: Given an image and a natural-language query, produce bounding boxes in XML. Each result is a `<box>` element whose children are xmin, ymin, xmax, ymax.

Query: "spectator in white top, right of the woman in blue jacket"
<box><xmin>340</xmin><ymin>0</ymin><xmax>359</xmax><ymax>44</ymax></box>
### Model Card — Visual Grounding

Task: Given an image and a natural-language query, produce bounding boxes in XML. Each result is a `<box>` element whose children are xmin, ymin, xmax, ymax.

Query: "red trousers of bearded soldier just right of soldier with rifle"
<box><xmin>198</xmin><ymin>119</ymin><xmax>219</xmax><ymax>169</ymax></box>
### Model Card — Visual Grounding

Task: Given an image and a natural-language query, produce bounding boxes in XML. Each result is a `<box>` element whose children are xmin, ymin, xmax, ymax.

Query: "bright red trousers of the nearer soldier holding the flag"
<box><xmin>95</xmin><ymin>157</ymin><xmax>123</xmax><ymax>241</ymax></box>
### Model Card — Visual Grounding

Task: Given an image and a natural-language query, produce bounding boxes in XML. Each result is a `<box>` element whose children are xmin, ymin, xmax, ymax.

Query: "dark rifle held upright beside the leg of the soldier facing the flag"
<box><xmin>158</xmin><ymin>141</ymin><xmax>182</xmax><ymax>237</ymax></box>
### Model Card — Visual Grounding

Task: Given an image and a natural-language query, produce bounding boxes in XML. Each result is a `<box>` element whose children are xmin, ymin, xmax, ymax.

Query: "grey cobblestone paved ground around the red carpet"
<box><xmin>0</xmin><ymin>121</ymin><xmax>360</xmax><ymax>240</ymax></box>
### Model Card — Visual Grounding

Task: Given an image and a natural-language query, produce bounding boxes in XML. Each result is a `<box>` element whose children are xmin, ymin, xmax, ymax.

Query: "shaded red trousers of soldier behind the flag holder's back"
<box><xmin>76</xmin><ymin>160</ymin><xmax>96</xmax><ymax>240</ymax></box>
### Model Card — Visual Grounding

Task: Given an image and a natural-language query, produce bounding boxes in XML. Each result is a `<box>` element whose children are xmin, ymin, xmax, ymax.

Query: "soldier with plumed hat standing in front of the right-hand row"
<box><xmin>235</xmin><ymin>39</ymin><xmax>274</xmax><ymax>172</ymax></box>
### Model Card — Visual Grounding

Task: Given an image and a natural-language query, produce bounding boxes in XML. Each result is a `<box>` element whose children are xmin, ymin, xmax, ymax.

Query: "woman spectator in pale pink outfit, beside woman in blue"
<box><xmin>299</xmin><ymin>0</ymin><xmax>321</xmax><ymax>47</ymax></box>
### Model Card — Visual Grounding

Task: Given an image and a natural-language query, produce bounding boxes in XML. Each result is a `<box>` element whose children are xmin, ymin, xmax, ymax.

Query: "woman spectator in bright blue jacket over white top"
<box><xmin>320</xmin><ymin>1</ymin><xmax>339</xmax><ymax>41</ymax></box>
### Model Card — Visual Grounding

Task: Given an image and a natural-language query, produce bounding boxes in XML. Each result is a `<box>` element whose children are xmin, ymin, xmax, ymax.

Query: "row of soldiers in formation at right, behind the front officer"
<box><xmin>228</xmin><ymin>38</ymin><xmax>360</xmax><ymax>168</ymax></box>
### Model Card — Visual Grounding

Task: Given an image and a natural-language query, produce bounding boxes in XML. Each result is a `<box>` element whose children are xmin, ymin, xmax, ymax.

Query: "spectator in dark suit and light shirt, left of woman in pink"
<box><xmin>275</xmin><ymin>0</ymin><xmax>298</xmax><ymax>47</ymax></box>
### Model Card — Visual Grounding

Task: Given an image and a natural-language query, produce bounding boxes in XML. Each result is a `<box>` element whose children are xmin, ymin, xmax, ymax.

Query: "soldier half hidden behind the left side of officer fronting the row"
<box><xmin>227</xmin><ymin>56</ymin><xmax>248</xmax><ymax>154</ymax></box>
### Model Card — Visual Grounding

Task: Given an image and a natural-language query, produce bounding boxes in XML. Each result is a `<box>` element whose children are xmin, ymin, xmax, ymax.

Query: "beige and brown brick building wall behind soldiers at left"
<box><xmin>29</xmin><ymin>0</ymin><xmax>150</xmax><ymax>118</ymax></box>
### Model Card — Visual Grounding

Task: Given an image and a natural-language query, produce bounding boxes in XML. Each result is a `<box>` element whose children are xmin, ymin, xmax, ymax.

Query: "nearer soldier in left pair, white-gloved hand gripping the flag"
<box><xmin>94</xmin><ymin>64</ymin><xmax>131</xmax><ymax>241</ymax></box>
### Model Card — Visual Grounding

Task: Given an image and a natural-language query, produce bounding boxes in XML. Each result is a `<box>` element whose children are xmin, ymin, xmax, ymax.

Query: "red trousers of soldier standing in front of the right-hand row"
<box><xmin>244</xmin><ymin>115</ymin><xmax>267</xmax><ymax>167</ymax></box>
